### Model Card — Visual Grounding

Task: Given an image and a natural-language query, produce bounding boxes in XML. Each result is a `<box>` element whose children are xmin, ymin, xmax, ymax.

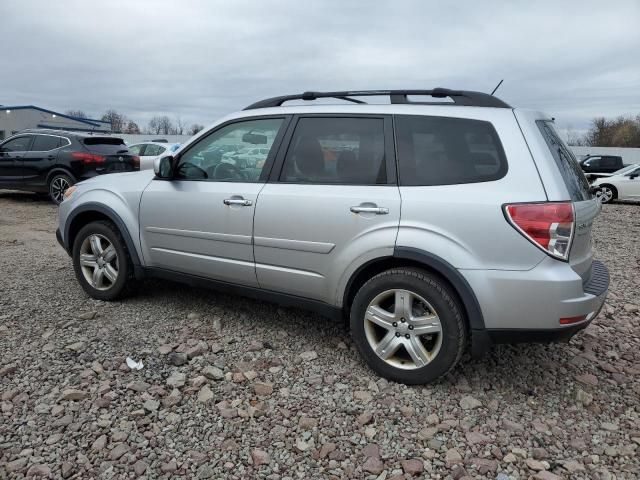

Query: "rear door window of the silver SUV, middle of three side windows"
<box><xmin>280</xmin><ymin>117</ymin><xmax>387</xmax><ymax>185</ymax></box>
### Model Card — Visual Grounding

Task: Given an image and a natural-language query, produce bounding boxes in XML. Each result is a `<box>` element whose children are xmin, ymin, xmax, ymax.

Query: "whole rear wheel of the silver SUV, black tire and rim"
<box><xmin>350</xmin><ymin>268</ymin><xmax>467</xmax><ymax>384</ymax></box>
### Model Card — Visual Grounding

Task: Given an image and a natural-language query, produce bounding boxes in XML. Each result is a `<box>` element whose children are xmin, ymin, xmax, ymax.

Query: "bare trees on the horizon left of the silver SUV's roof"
<box><xmin>65</xmin><ymin>109</ymin><xmax>204</xmax><ymax>135</ymax></box>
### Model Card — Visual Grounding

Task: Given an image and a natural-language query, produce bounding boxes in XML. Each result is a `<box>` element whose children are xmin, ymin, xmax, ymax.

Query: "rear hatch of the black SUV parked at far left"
<box><xmin>82</xmin><ymin>136</ymin><xmax>140</xmax><ymax>173</ymax></box>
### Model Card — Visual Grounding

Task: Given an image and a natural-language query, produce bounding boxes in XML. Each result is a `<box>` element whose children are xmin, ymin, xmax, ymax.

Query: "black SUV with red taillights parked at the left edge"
<box><xmin>0</xmin><ymin>130</ymin><xmax>140</xmax><ymax>203</ymax></box>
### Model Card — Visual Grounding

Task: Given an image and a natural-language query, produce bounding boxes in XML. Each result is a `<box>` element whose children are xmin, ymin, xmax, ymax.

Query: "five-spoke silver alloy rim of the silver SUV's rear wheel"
<box><xmin>365</xmin><ymin>289</ymin><xmax>442</xmax><ymax>370</ymax></box>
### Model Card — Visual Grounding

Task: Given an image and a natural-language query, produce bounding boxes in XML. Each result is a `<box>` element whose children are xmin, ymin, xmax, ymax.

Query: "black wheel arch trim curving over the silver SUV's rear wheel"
<box><xmin>342</xmin><ymin>247</ymin><xmax>487</xmax><ymax>346</ymax></box>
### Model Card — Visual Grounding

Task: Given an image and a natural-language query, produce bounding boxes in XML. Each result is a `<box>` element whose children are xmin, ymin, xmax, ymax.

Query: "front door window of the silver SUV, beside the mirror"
<box><xmin>176</xmin><ymin>118</ymin><xmax>284</xmax><ymax>182</ymax></box>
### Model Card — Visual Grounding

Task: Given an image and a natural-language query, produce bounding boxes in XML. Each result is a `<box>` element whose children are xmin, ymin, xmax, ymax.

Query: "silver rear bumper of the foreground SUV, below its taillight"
<box><xmin>461</xmin><ymin>258</ymin><xmax>609</xmax><ymax>355</ymax></box>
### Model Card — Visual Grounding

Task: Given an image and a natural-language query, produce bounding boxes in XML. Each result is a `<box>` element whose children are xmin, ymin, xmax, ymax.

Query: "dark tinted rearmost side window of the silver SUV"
<box><xmin>395</xmin><ymin>115</ymin><xmax>508</xmax><ymax>186</ymax></box>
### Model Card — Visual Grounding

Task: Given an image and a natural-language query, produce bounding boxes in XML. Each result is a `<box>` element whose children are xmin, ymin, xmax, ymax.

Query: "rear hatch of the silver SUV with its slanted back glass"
<box><xmin>536</xmin><ymin>120</ymin><xmax>602</xmax><ymax>283</ymax></box>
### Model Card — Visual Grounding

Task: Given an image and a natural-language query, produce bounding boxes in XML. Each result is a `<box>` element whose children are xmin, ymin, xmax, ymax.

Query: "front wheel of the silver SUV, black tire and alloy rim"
<box><xmin>73</xmin><ymin>221</ymin><xmax>133</xmax><ymax>300</ymax></box>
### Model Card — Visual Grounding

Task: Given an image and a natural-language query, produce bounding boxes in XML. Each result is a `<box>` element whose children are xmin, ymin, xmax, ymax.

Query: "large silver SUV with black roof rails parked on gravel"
<box><xmin>57</xmin><ymin>89</ymin><xmax>609</xmax><ymax>383</ymax></box>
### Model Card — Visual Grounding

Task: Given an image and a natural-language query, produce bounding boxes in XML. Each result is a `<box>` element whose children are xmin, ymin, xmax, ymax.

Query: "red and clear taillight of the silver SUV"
<box><xmin>504</xmin><ymin>202</ymin><xmax>574</xmax><ymax>261</ymax></box>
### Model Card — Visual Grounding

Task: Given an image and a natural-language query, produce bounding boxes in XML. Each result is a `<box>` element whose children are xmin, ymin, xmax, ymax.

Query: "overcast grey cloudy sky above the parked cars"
<box><xmin>0</xmin><ymin>0</ymin><xmax>640</xmax><ymax>137</ymax></box>
